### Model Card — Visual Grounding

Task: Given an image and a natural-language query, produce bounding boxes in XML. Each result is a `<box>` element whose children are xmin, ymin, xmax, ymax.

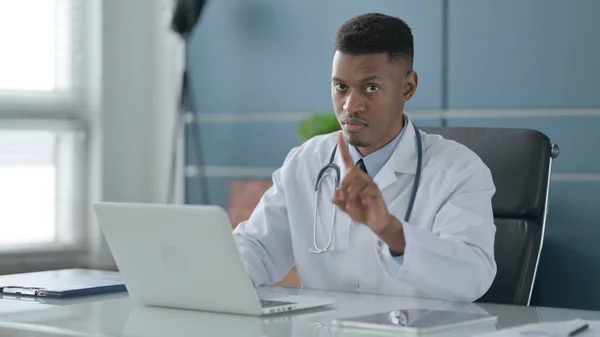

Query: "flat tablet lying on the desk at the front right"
<box><xmin>332</xmin><ymin>309</ymin><xmax>498</xmax><ymax>334</ymax></box>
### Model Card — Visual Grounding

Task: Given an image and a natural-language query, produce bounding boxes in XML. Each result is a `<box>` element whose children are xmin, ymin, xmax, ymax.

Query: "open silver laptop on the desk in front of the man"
<box><xmin>93</xmin><ymin>202</ymin><xmax>335</xmax><ymax>316</ymax></box>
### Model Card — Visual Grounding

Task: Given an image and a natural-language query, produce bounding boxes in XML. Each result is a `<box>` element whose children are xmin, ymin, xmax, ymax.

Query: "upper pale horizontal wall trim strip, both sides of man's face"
<box><xmin>186</xmin><ymin>108</ymin><xmax>600</xmax><ymax>124</ymax></box>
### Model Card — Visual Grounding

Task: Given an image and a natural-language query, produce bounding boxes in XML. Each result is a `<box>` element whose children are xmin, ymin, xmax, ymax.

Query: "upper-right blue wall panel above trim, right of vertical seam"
<box><xmin>447</xmin><ymin>0</ymin><xmax>600</xmax><ymax>109</ymax></box>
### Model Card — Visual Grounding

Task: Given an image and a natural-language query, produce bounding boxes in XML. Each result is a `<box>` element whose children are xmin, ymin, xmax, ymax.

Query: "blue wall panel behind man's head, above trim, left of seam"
<box><xmin>189</xmin><ymin>0</ymin><xmax>442</xmax><ymax>113</ymax></box>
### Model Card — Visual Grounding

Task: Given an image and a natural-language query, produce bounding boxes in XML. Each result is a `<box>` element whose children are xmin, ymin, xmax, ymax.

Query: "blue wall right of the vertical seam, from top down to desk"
<box><xmin>446</xmin><ymin>0</ymin><xmax>600</xmax><ymax>310</ymax></box>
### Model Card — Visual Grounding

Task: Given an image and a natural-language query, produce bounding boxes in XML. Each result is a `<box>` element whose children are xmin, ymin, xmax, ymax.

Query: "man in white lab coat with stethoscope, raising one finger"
<box><xmin>234</xmin><ymin>14</ymin><xmax>496</xmax><ymax>301</ymax></box>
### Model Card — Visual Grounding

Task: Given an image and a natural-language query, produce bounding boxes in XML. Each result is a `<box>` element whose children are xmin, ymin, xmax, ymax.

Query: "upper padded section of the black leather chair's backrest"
<box><xmin>421</xmin><ymin>127</ymin><xmax>552</xmax><ymax>218</ymax></box>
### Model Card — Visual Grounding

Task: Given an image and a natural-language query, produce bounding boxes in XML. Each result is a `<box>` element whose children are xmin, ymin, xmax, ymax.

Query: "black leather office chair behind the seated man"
<box><xmin>421</xmin><ymin>127</ymin><xmax>558</xmax><ymax>305</ymax></box>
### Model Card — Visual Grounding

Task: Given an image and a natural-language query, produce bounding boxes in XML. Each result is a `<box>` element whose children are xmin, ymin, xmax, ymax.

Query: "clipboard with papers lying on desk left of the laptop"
<box><xmin>0</xmin><ymin>275</ymin><xmax>127</xmax><ymax>298</ymax></box>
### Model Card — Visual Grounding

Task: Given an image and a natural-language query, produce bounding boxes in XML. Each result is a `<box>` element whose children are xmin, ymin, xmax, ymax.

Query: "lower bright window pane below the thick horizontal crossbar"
<box><xmin>0</xmin><ymin>131</ymin><xmax>56</xmax><ymax>247</ymax></box>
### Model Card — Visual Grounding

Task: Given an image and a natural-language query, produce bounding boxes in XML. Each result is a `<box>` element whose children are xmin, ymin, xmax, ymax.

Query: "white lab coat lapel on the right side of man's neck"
<box><xmin>374</xmin><ymin>118</ymin><xmax>417</xmax><ymax>191</ymax></box>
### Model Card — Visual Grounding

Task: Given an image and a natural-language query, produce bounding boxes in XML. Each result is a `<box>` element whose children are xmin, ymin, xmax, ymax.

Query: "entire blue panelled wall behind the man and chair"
<box><xmin>187</xmin><ymin>0</ymin><xmax>600</xmax><ymax>310</ymax></box>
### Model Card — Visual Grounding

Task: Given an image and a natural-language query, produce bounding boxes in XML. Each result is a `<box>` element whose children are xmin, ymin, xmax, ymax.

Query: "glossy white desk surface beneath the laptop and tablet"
<box><xmin>0</xmin><ymin>271</ymin><xmax>600</xmax><ymax>337</ymax></box>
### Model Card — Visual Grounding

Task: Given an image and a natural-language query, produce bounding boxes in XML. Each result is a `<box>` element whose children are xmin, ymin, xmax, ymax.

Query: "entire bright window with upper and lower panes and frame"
<box><xmin>0</xmin><ymin>0</ymin><xmax>90</xmax><ymax>253</ymax></box>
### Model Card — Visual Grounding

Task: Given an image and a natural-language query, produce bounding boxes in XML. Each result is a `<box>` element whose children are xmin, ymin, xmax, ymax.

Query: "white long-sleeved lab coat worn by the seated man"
<box><xmin>234</xmin><ymin>113</ymin><xmax>496</xmax><ymax>302</ymax></box>
